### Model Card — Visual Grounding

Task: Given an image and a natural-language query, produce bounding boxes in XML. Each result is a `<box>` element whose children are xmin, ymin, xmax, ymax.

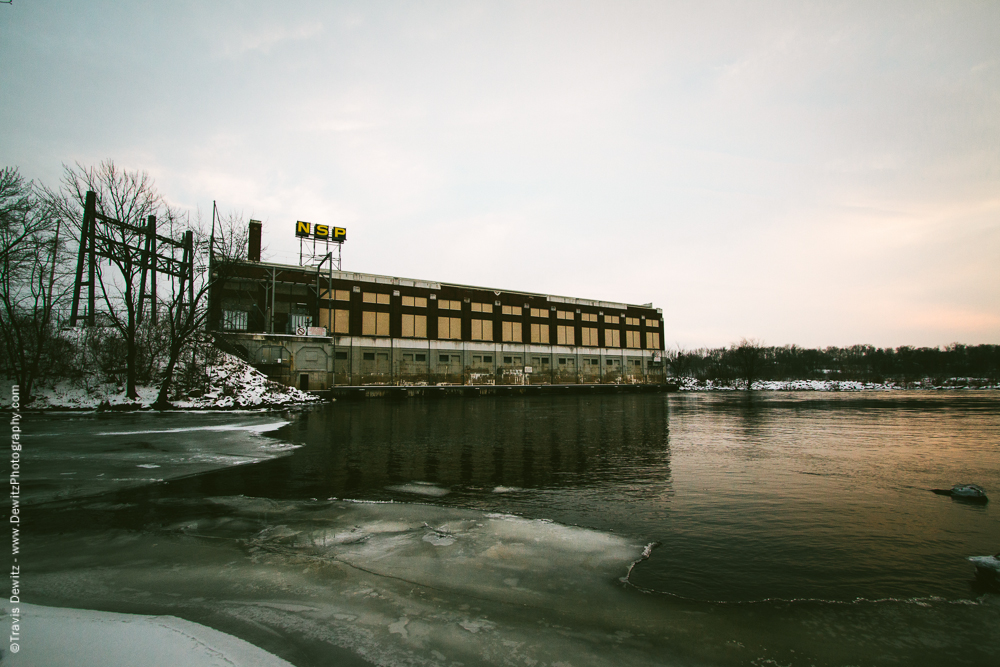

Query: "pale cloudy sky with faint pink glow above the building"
<box><xmin>0</xmin><ymin>0</ymin><xmax>1000</xmax><ymax>349</ymax></box>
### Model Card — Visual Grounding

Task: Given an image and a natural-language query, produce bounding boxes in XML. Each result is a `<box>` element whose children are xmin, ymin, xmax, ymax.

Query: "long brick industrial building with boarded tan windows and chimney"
<box><xmin>209</xmin><ymin>221</ymin><xmax>665</xmax><ymax>390</ymax></box>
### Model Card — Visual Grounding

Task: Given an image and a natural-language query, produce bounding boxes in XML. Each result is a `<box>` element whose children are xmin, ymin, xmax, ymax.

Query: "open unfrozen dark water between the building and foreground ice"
<box><xmin>158</xmin><ymin>392</ymin><xmax>1000</xmax><ymax>601</ymax></box>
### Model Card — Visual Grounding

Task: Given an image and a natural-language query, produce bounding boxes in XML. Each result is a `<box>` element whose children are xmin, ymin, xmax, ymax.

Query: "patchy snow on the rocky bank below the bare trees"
<box><xmin>6</xmin><ymin>352</ymin><xmax>320</xmax><ymax>410</ymax></box>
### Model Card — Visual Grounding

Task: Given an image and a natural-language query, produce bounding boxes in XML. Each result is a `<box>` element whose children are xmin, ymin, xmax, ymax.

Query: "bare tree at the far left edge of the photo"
<box><xmin>0</xmin><ymin>167</ymin><xmax>66</xmax><ymax>403</ymax></box>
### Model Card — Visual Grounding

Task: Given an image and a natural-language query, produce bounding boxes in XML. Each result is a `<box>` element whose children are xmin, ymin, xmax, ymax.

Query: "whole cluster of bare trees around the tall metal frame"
<box><xmin>0</xmin><ymin>160</ymin><xmax>247</xmax><ymax>407</ymax></box>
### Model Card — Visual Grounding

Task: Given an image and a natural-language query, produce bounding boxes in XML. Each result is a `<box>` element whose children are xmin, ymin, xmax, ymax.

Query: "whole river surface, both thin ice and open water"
<box><xmin>13</xmin><ymin>391</ymin><xmax>1000</xmax><ymax>666</ymax></box>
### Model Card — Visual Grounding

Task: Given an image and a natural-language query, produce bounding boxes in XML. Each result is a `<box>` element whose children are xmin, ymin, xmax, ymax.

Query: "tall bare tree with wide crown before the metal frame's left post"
<box><xmin>46</xmin><ymin>160</ymin><xmax>166</xmax><ymax>399</ymax></box>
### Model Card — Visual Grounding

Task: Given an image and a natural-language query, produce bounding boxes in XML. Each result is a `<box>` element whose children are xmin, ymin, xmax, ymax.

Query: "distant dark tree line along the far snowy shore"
<box><xmin>667</xmin><ymin>339</ymin><xmax>1000</xmax><ymax>386</ymax></box>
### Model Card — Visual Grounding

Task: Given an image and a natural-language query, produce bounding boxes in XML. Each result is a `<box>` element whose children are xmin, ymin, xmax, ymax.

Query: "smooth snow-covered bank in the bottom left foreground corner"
<box><xmin>3</xmin><ymin>604</ymin><xmax>292</xmax><ymax>667</ymax></box>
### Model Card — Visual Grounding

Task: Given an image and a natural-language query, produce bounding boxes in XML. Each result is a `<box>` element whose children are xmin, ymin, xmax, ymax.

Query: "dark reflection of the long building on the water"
<box><xmin>158</xmin><ymin>396</ymin><xmax>671</xmax><ymax>499</ymax></box>
